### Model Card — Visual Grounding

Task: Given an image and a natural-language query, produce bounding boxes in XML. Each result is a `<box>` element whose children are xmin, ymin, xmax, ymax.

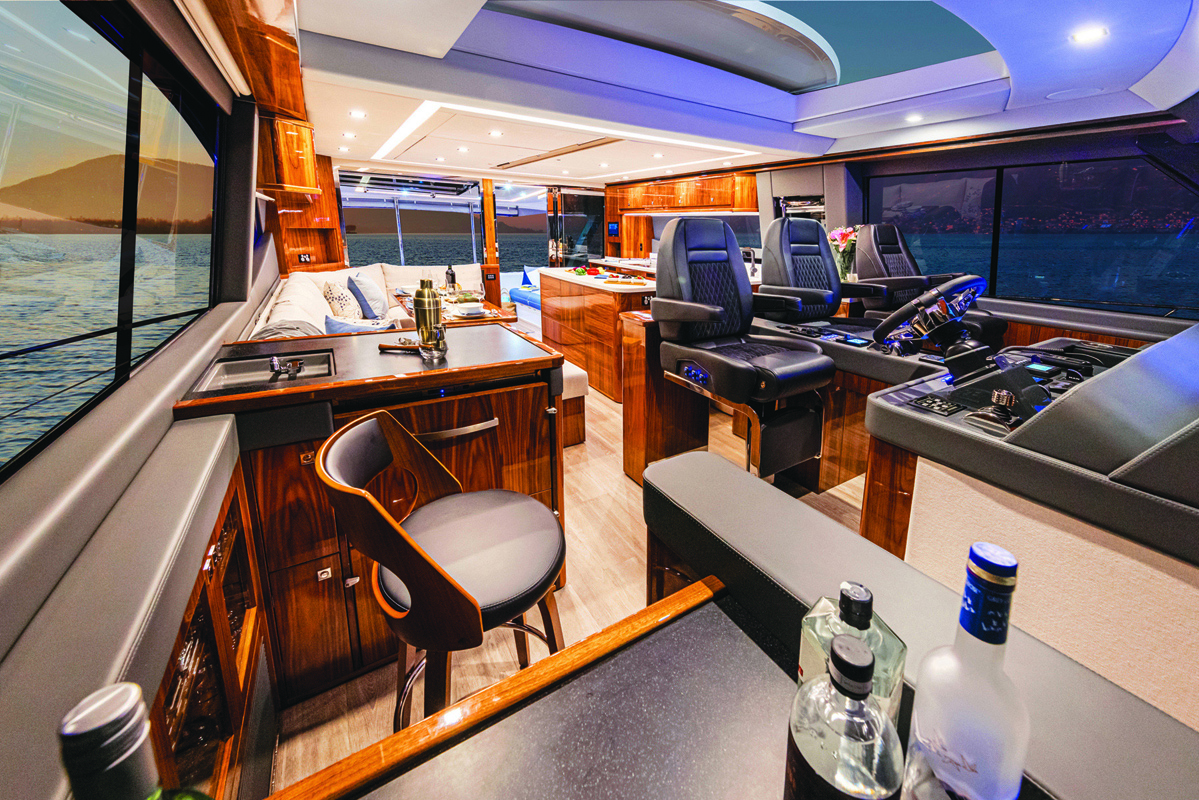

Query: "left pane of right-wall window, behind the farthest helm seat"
<box><xmin>869</xmin><ymin>169</ymin><xmax>1007</xmax><ymax>278</ymax></box>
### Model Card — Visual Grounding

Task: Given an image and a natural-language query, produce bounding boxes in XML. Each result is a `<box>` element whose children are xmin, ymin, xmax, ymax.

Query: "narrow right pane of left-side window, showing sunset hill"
<box><xmin>133</xmin><ymin>54</ymin><xmax>216</xmax><ymax>327</ymax></box>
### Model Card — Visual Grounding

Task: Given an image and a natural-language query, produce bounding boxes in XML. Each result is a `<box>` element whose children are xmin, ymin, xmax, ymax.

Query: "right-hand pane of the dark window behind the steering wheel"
<box><xmin>995</xmin><ymin>158</ymin><xmax>1199</xmax><ymax>314</ymax></box>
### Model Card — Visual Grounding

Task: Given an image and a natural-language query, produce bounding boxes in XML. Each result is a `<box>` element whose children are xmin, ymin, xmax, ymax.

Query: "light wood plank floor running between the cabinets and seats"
<box><xmin>272</xmin><ymin>392</ymin><xmax>864</xmax><ymax>790</ymax></box>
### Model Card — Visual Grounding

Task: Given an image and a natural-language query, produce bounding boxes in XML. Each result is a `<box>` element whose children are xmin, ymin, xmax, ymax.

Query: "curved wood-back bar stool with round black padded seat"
<box><xmin>317</xmin><ymin>411</ymin><xmax>566</xmax><ymax>730</ymax></box>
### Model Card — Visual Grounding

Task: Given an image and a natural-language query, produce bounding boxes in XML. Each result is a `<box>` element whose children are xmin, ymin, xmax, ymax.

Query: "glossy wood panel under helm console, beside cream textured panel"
<box><xmin>858</xmin><ymin>437</ymin><xmax>916</xmax><ymax>558</ymax></box>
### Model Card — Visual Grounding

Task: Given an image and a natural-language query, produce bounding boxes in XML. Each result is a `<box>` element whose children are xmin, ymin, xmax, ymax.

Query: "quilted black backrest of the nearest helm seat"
<box><xmin>657</xmin><ymin>217</ymin><xmax>753</xmax><ymax>341</ymax></box>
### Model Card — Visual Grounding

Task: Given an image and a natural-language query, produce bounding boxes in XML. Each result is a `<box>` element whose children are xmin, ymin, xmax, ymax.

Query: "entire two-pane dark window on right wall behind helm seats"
<box><xmin>868</xmin><ymin>157</ymin><xmax>1199</xmax><ymax>318</ymax></box>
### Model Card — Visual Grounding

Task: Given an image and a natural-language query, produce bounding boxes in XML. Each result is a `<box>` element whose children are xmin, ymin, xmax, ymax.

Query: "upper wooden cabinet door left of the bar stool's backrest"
<box><xmin>249</xmin><ymin>441</ymin><xmax>337</xmax><ymax>572</ymax></box>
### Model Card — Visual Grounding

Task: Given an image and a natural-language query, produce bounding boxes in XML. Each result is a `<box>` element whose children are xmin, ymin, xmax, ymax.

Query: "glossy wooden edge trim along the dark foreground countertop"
<box><xmin>270</xmin><ymin>577</ymin><xmax>724</xmax><ymax>800</ymax></box>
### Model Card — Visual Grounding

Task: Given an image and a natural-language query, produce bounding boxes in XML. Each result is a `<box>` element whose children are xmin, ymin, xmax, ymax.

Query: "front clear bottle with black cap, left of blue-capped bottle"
<box><xmin>783</xmin><ymin>633</ymin><xmax>903</xmax><ymax>800</ymax></box>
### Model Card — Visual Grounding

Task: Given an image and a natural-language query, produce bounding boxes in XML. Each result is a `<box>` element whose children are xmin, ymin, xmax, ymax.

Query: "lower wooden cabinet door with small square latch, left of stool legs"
<box><xmin>270</xmin><ymin>553</ymin><xmax>354</xmax><ymax>699</ymax></box>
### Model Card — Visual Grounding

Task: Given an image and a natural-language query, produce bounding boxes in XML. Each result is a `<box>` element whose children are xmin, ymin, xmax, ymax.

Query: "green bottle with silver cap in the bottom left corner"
<box><xmin>59</xmin><ymin>684</ymin><xmax>211</xmax><ymax>800</ymax></box>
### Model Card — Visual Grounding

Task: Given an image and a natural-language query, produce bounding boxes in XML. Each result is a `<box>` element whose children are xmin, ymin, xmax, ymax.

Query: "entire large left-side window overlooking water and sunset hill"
<box><xmin>0</xmin><ymin>2</ymin><xmax>219</xmax><ymax>477</ymax></box>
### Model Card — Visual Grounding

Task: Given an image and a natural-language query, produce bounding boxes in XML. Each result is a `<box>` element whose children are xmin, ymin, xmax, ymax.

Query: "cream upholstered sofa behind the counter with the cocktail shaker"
<box><xmin>247</xmin><ymin>264</ymin><xmax>483</xmax><ymax>339</ymax></box>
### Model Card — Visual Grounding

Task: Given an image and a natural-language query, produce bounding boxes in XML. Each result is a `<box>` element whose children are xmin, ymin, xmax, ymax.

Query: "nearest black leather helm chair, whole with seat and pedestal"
<box><xmin>650</xmin><ymin>217</ymin><xmax>833</xmax><ymax>476</ymax></box>
